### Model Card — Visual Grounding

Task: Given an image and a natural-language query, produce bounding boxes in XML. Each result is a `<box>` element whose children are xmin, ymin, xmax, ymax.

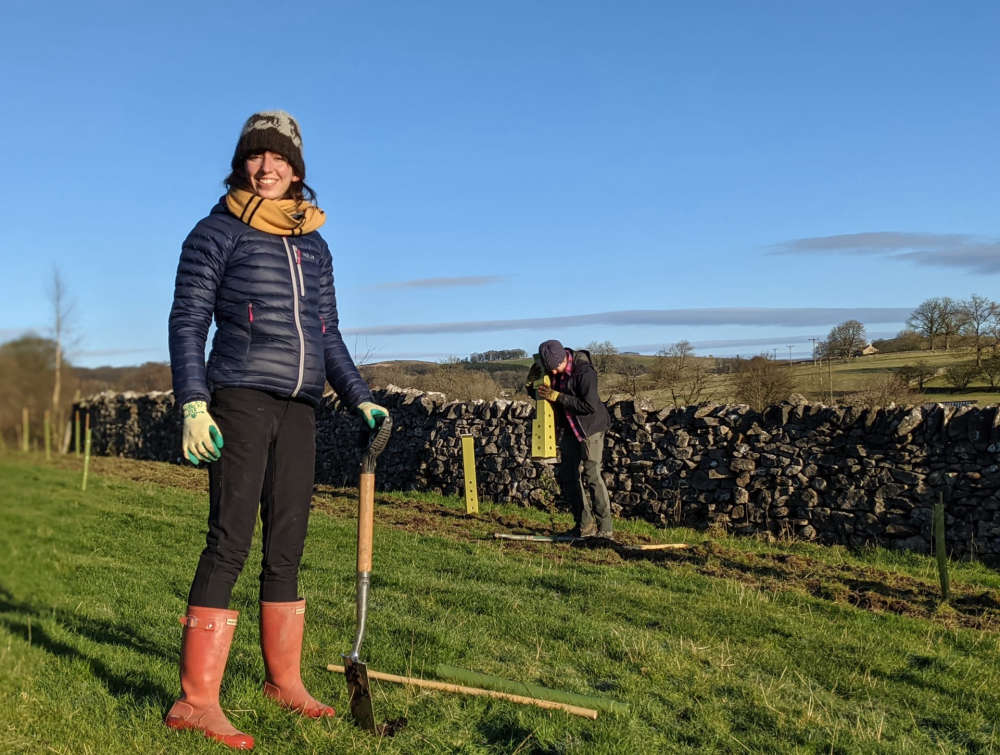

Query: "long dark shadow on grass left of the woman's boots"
<box><xmin>0</xmin><ymin>585</ymin><xmax>176</xmax><ymax>709</ymax></box>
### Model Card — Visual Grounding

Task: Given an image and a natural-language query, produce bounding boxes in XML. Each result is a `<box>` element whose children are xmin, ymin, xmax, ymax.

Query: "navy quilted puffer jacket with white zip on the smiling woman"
<box><xmin>169</xmin><ymin>201</ymin><xmax>371</xmax><ymax>407</ymax></box>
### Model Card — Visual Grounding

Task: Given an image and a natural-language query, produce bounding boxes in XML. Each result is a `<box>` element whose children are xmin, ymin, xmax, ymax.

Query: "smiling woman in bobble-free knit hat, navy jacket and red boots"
<box><xmin>166</xmin><ymin>110</ymin><xmax>388</xmax><ymax>749</ymax></box>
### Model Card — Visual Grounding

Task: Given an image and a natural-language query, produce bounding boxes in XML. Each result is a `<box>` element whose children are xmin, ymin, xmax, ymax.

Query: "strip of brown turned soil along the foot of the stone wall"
<box><xmin>64</xmin><ymin>456</ymin><xmax>1000</xmax><ymax>632</ymax></box>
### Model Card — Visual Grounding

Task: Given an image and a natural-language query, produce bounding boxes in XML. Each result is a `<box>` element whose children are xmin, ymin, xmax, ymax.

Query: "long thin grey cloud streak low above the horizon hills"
<box><xmin>343</xmin><ymin>307</ymin><xmax>913</xmax><ymax>336</ymax></box>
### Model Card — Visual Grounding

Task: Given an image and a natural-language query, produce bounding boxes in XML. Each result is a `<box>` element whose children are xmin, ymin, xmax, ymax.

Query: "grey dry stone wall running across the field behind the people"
<box><xmin>78</xmin><ymin>388</ymin><xmax>1000</xmax><ymax>562</ymax></box>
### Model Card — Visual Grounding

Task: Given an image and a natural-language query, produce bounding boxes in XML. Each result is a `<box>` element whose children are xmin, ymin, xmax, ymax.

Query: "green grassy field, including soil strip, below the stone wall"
<box><xmin>0</xmin><ymin>453</ymin><xmax>1000</xmax><ymax>753</ymax></box>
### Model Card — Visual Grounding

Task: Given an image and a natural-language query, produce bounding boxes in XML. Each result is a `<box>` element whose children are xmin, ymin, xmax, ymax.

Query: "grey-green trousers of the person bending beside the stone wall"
<box><xmin>559</xmin><ymin>429</ymin><xmax>612</xmax><ymax>532</ymax></box>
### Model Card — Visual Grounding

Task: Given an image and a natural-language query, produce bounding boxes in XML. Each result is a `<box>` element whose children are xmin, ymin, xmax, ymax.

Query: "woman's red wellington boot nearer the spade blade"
<box><xmin>260</xmin><ymin>600</ymin><xmax>336</xmax><ymax>718</ymax></box>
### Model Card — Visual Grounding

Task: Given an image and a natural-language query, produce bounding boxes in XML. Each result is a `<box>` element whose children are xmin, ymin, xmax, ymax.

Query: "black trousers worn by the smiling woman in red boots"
<box><xmin>188</xmin><ymin>388</ymin><xmax>316</xmax><ymax>608</ymax></box>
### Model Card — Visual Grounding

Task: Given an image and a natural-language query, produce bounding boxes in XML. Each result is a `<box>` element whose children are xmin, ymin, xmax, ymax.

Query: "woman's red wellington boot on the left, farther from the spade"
<box><xmin>164</xmin><ymin>606</ymin><xmax>253</xmax><ymax>750</ymax></box>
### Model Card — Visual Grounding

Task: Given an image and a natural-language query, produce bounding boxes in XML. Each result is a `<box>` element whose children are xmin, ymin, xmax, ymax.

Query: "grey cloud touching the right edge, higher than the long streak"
<box><xmin>769</xmin><ymin>231</ymin><xmax>1000</xmax><ymax>275</ymax></box>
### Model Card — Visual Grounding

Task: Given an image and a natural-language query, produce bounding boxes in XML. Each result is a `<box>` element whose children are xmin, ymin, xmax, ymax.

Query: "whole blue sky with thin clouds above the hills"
<box><xmin>0</xmin><ymin>0</ymin><xmax>1000</xmax><ymax>366</ymax></box>
